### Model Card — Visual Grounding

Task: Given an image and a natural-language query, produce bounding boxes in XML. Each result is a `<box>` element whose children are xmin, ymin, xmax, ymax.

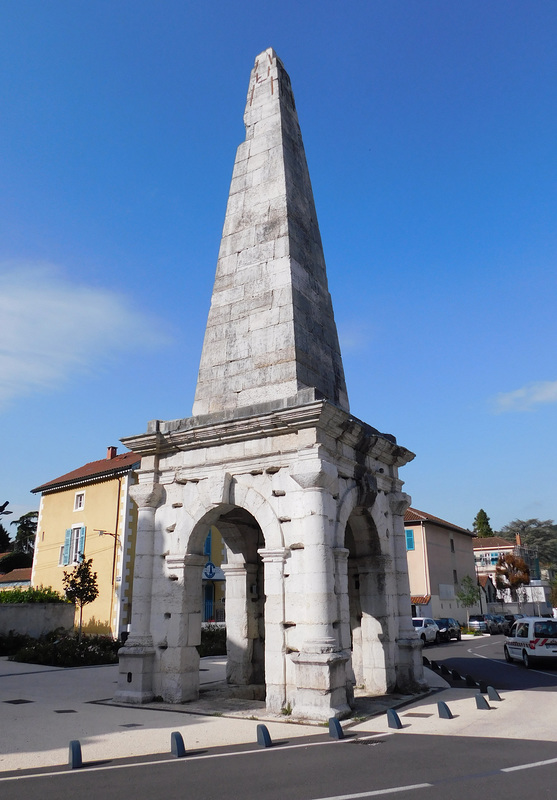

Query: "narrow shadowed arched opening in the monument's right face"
<box><xmin>345</xmin><ymin>508</ymin><xmax>388</xmax><ymax>694</ymax></box>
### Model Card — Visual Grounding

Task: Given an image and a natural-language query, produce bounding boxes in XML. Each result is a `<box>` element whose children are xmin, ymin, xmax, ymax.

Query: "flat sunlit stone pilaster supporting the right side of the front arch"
<box><xmin>258</xmin><ymin>548</ymin><xmax>292</xmax><ymax>713</ymax></box>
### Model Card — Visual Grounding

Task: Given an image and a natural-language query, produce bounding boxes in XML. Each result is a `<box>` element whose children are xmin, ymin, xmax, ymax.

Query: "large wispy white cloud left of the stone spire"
<box><xmin>0</xmin><ymin>262</ymin><xmax>166</xmax><ymax>407</ymax></box>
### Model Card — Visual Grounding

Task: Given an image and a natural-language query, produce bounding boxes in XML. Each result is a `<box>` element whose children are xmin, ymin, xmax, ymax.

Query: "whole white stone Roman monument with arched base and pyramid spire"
<box><xmin>116</xmin><ymin>49</ymin><xmax>423</xmax><ymax>720</ymax></box>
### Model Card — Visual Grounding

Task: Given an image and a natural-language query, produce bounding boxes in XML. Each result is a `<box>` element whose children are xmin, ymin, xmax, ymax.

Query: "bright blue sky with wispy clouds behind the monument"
<box><xmin>0</xmin><ymin>0</ymin><xmax>557</xmax><ymax>529</ymax></box>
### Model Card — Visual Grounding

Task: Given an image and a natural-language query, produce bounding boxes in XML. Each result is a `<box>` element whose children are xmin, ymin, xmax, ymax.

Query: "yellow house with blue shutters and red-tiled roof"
<box><xmin>31</xmin><ymin>447</ymin><xmax>140</xmax><ymax>637</ymax></box>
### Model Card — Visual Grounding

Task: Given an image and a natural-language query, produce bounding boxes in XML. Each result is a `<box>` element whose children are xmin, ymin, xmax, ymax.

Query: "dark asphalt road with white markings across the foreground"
<box><xmin>0</xmin><ymin>734</ymin><xmax>557</xmax><ymax>800</ymax></box>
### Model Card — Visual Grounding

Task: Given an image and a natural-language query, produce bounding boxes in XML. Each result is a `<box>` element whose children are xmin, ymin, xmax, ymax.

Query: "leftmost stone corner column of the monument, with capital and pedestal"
<box><xmin>114</xmin><ymin>482</ymin><xmax>164</xmax><ymax>703</ymax></box>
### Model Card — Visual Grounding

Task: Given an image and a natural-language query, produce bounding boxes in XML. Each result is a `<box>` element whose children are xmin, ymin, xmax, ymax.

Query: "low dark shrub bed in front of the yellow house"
<box><xmin>10</xmin><ymin>631</ymin><xmax>121</xmax><ymax>667</ymax></box>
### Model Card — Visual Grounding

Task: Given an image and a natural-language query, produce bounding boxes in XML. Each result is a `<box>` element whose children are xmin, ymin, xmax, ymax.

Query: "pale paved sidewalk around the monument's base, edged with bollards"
<box><xmin>0</xmin><ymin>658</ymin><xmax>557</xmax><ymax>772</ymax></box>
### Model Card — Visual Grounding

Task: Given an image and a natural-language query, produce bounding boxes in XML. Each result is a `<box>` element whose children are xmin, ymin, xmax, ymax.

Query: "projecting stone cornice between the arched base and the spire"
<box><xmin>121</xmin><ymin>400</ymin><xmax>414</xmax><ymax>467</ymax></box>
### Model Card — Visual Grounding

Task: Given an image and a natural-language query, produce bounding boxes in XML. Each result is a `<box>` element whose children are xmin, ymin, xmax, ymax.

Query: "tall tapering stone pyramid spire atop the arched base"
<box><xmin>193</xmin><ymin>48</ymin><xmax>348</xmax><ymax>416</ymax></box>
